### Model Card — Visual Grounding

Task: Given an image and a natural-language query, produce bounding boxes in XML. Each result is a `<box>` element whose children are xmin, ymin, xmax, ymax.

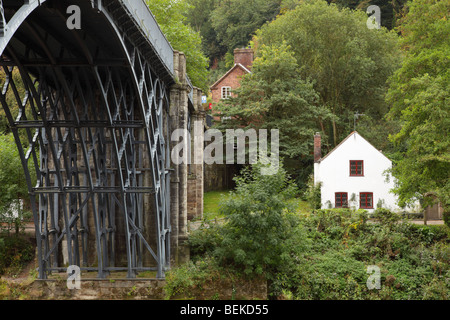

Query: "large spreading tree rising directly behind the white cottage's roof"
<box><xmin>254</xmin><ymin>0</ymin><xmax>400</xmax><ymax>145</ymax></box>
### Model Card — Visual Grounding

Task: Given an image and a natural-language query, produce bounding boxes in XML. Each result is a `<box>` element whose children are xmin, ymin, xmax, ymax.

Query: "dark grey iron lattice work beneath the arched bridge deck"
<box><xmin>0</xmin><ymin>1</ymin><xmax>170</xmax><ymax>279</ymax></box>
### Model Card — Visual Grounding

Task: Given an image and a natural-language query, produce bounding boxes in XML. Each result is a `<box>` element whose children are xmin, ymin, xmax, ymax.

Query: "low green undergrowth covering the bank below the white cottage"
<box><xmin>185</xmin><ymin>201</ymin><xmax>450</xmax><ymax>300</ymax></box>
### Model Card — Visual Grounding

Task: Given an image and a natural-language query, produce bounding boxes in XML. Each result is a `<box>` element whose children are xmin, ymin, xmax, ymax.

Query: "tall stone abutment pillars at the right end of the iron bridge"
<box><xmin>170</xmin><ymin>51</ymin><xmax>205</xmax><ymax>264</ymax></box>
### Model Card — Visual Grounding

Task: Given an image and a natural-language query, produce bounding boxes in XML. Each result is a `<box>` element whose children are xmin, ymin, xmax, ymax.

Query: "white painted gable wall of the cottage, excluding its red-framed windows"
<box><xmin>314</xmin><ymin>132</ymin><xmax>418</xmax><ymax>212</ymax></box>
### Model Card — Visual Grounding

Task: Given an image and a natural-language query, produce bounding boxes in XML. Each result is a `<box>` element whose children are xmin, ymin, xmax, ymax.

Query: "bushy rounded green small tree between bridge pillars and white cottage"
<box><xmin>214</xmin><ymin>164</ymin><xmax>304</xmax><ymax>296</ymax></box>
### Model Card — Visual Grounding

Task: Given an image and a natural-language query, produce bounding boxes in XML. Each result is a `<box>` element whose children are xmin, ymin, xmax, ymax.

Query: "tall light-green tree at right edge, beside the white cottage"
<box><xmin>387</xmin><ymin>0</ymin><xmax>450</xmax><ymax>212</ymax></box>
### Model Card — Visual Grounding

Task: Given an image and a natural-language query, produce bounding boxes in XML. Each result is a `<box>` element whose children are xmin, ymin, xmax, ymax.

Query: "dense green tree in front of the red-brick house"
<box><xmin>217</xmin><ymin>43</ymin><xmax>329</xmax><ymax>158</ymax></box>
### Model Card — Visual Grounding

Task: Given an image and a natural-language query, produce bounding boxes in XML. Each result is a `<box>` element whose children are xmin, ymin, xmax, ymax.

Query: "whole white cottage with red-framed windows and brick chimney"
<box><xmin>314</xmin><ymin>131</ymin><xmax>414</xmax><ymax>212</ymax></box>
